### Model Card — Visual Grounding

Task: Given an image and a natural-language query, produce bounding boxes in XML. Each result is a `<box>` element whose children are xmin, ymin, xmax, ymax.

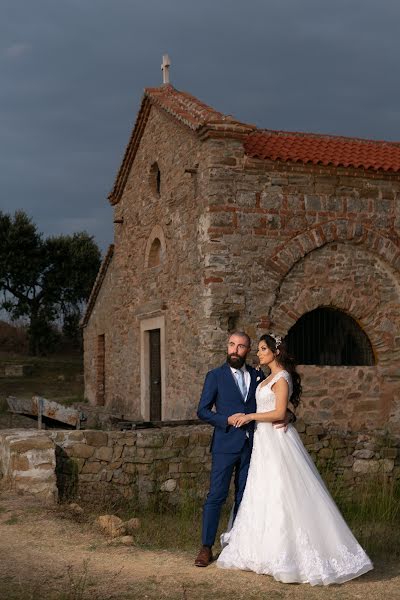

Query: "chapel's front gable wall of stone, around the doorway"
<box><xmin>85</xmin><ymin>107</ymin><xmax>217</xmax><ymax>419</ymax></box>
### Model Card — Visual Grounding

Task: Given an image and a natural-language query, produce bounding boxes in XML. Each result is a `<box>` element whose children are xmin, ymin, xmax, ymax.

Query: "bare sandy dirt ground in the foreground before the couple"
<box><xmin>0</xmin><ymin>493</ymin><xmax>400</xmax><ymax>600</ymax></box>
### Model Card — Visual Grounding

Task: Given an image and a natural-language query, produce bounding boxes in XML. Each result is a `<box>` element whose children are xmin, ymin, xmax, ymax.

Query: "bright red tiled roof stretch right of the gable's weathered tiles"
<box><xmin>244</xmin><ymin>130</ymin><xmax>400</xmax><ymax>172</ymax></box>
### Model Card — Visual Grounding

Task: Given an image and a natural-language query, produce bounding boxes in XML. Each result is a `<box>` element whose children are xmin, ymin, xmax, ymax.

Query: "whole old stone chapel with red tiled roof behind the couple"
<box><xmin>82</xmin><ymin>83</ymin><xmax>400</xmax><ymax>434</ymax></box>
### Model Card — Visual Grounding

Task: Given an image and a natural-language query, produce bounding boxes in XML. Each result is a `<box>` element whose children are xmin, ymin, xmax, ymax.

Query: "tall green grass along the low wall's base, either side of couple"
<box><xmin>91</xmin><ymin>478</ymin><xmax>400</xmax><ymax>560</ymax></box>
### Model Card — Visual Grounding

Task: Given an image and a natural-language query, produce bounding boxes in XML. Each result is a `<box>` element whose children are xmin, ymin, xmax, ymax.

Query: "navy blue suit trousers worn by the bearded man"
<box><xmin>202</xmin><ymin>439</ymin><xmax>251</xmax><ymax>546</ymax></box>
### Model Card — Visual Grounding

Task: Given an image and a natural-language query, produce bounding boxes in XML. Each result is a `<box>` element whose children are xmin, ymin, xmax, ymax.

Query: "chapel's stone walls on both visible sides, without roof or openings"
<box><xmin>81</xmin><ymin>95</ymin><xmax>400</xmax><ymax>434</ymax></box>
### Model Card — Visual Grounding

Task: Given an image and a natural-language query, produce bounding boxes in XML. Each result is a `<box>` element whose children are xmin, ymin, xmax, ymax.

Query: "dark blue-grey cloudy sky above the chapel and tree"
<box><xmin>0</xmin><ymin>0</ymin><xmax>400</xmax><ymax>251</ymax></box>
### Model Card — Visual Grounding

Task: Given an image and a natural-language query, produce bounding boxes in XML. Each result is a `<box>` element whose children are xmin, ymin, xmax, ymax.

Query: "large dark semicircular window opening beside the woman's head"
<box><xmin>287</xmin><ymin>307</ymin><xmax>375</xmax><ymax>366</ymax></box>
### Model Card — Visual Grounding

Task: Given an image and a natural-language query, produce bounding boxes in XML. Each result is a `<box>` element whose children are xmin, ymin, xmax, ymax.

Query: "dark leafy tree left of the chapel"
<box><xmin>0</xmin><ymin>211</ymin><xmax>100</xmax><ymax>355</ymax></box>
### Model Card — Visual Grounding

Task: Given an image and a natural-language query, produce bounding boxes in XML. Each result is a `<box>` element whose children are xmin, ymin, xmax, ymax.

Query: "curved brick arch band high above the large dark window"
<box><xmin>268</xmin><ymin>219</ymin><xmax>400</xmax><ymax>280</ymax></box>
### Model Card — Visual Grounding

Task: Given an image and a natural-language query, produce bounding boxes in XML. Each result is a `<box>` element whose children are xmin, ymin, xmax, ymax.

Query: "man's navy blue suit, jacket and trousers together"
<box><xmin>197</xmin><ymin>363</ymin><xmax>265</xmax><ymax>546</ymax></box>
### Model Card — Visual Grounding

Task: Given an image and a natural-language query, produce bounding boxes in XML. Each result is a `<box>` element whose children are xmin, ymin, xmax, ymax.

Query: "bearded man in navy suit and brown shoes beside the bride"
<box><xmin>194</xmin><ymin>331</ymin><xmax>272</xmax><ymax>567</ymax></box>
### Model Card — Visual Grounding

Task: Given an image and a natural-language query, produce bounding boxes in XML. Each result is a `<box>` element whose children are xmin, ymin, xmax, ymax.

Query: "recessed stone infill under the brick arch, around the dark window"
<box><xmin>270</xmin><ymin>238</ymin><xmax>400</xmax><ymax>432</ymax></box>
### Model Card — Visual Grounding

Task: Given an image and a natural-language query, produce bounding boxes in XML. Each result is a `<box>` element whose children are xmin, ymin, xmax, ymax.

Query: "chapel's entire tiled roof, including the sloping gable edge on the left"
<box><xmin>109</xmin><ymin>84</ymin><xmax>400</xmax><ymax>204</ymax></box>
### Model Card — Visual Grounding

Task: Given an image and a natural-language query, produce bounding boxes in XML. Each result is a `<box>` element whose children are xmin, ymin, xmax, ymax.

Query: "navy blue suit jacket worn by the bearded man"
<box><xmin>197</xmin><ymin>362</ymin><xmax>265</xmax><ymax>453</ymax></box>
